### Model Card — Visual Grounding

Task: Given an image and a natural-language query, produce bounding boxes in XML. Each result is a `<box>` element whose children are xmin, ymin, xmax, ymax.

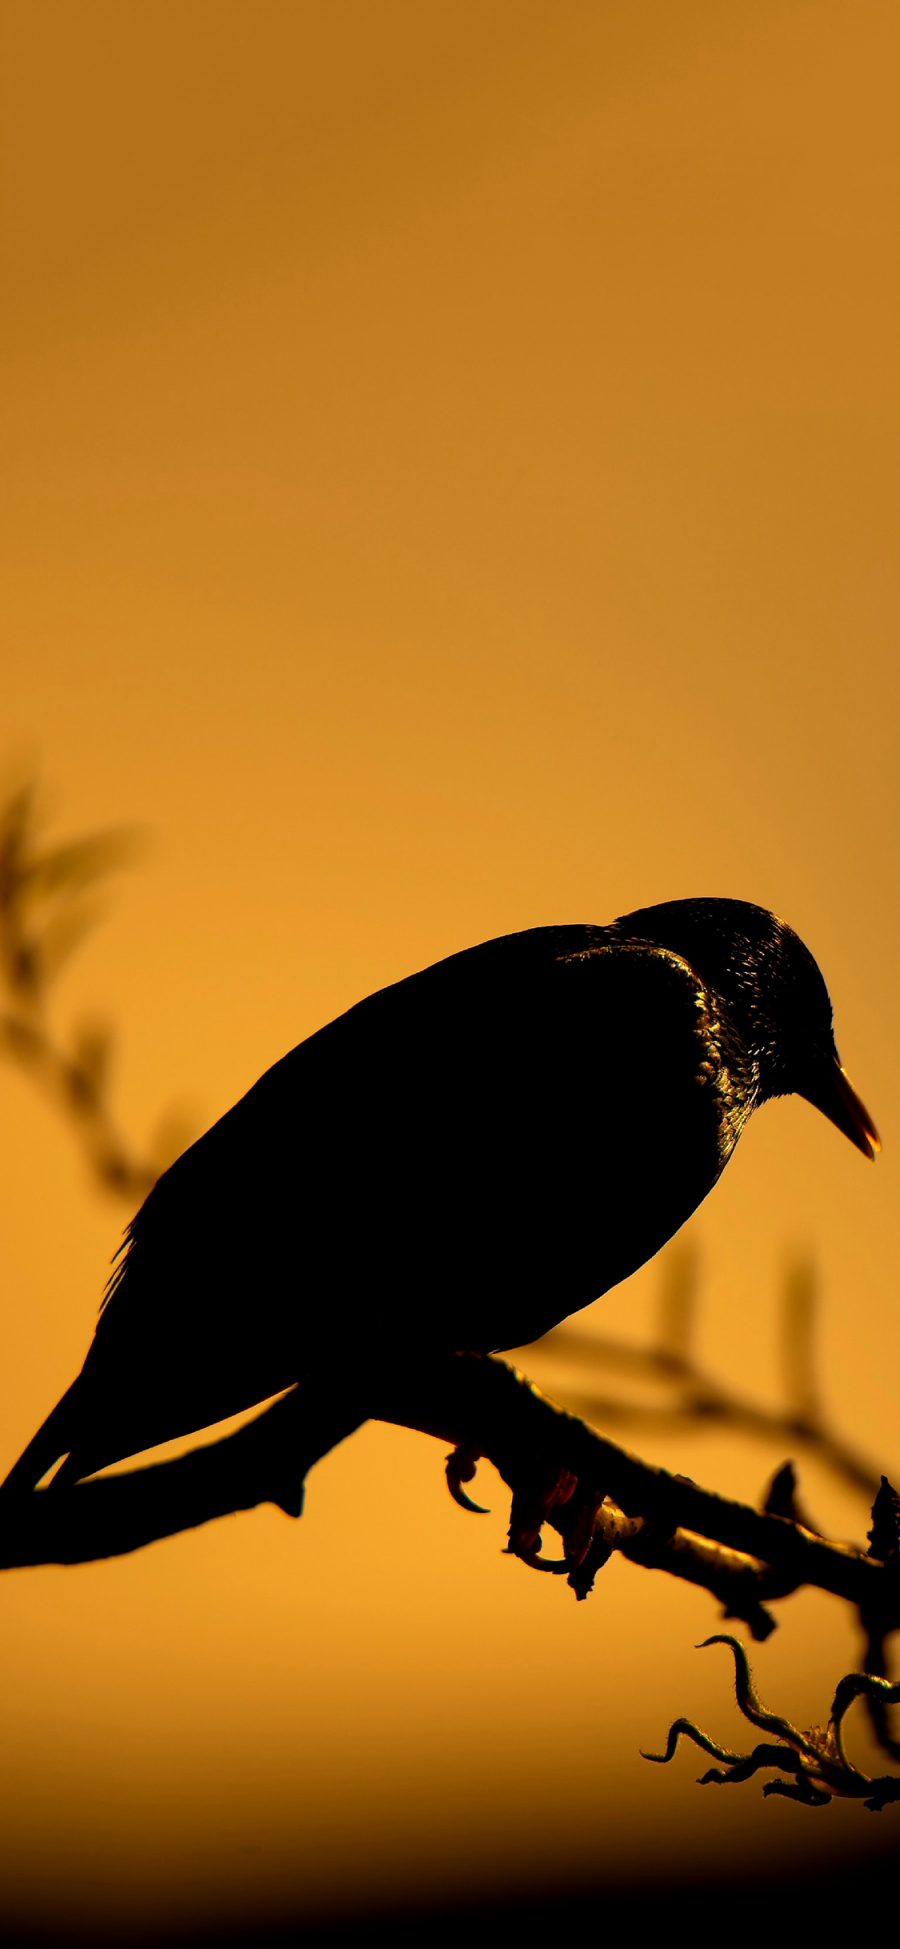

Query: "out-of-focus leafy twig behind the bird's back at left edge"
<box><xmin>0</xmin><ymin>785</ymin><xmax>187</xmax><ymax>1203</ymax></box>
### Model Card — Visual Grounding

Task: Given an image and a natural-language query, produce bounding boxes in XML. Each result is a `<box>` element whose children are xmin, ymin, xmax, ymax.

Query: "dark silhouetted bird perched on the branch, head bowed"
<box><xmin>2</xmin><ymin>898</ymin><xmax>881</xmax><ymax>1493</ymax></box>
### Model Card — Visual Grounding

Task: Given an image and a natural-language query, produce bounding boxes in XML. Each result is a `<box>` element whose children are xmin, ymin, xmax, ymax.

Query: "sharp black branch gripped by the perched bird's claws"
<box><xmin>0</xmin><ymin>1355</ymin><xmax>900</xmax><ymax>1660</ymax></box>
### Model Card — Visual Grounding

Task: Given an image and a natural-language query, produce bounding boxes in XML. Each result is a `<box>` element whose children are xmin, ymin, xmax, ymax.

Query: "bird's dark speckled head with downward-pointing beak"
<box><xmin>616</xmin><ymin>898</ymin><xmax>881</xmax><ymax>1158</ymax></box>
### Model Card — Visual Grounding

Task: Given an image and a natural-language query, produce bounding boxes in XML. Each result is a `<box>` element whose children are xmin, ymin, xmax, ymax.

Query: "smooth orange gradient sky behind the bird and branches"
<box><xmin>0</xmin><ymin>0</ymin><xmax>900</xmax><ymax>1935</ymax></box>
